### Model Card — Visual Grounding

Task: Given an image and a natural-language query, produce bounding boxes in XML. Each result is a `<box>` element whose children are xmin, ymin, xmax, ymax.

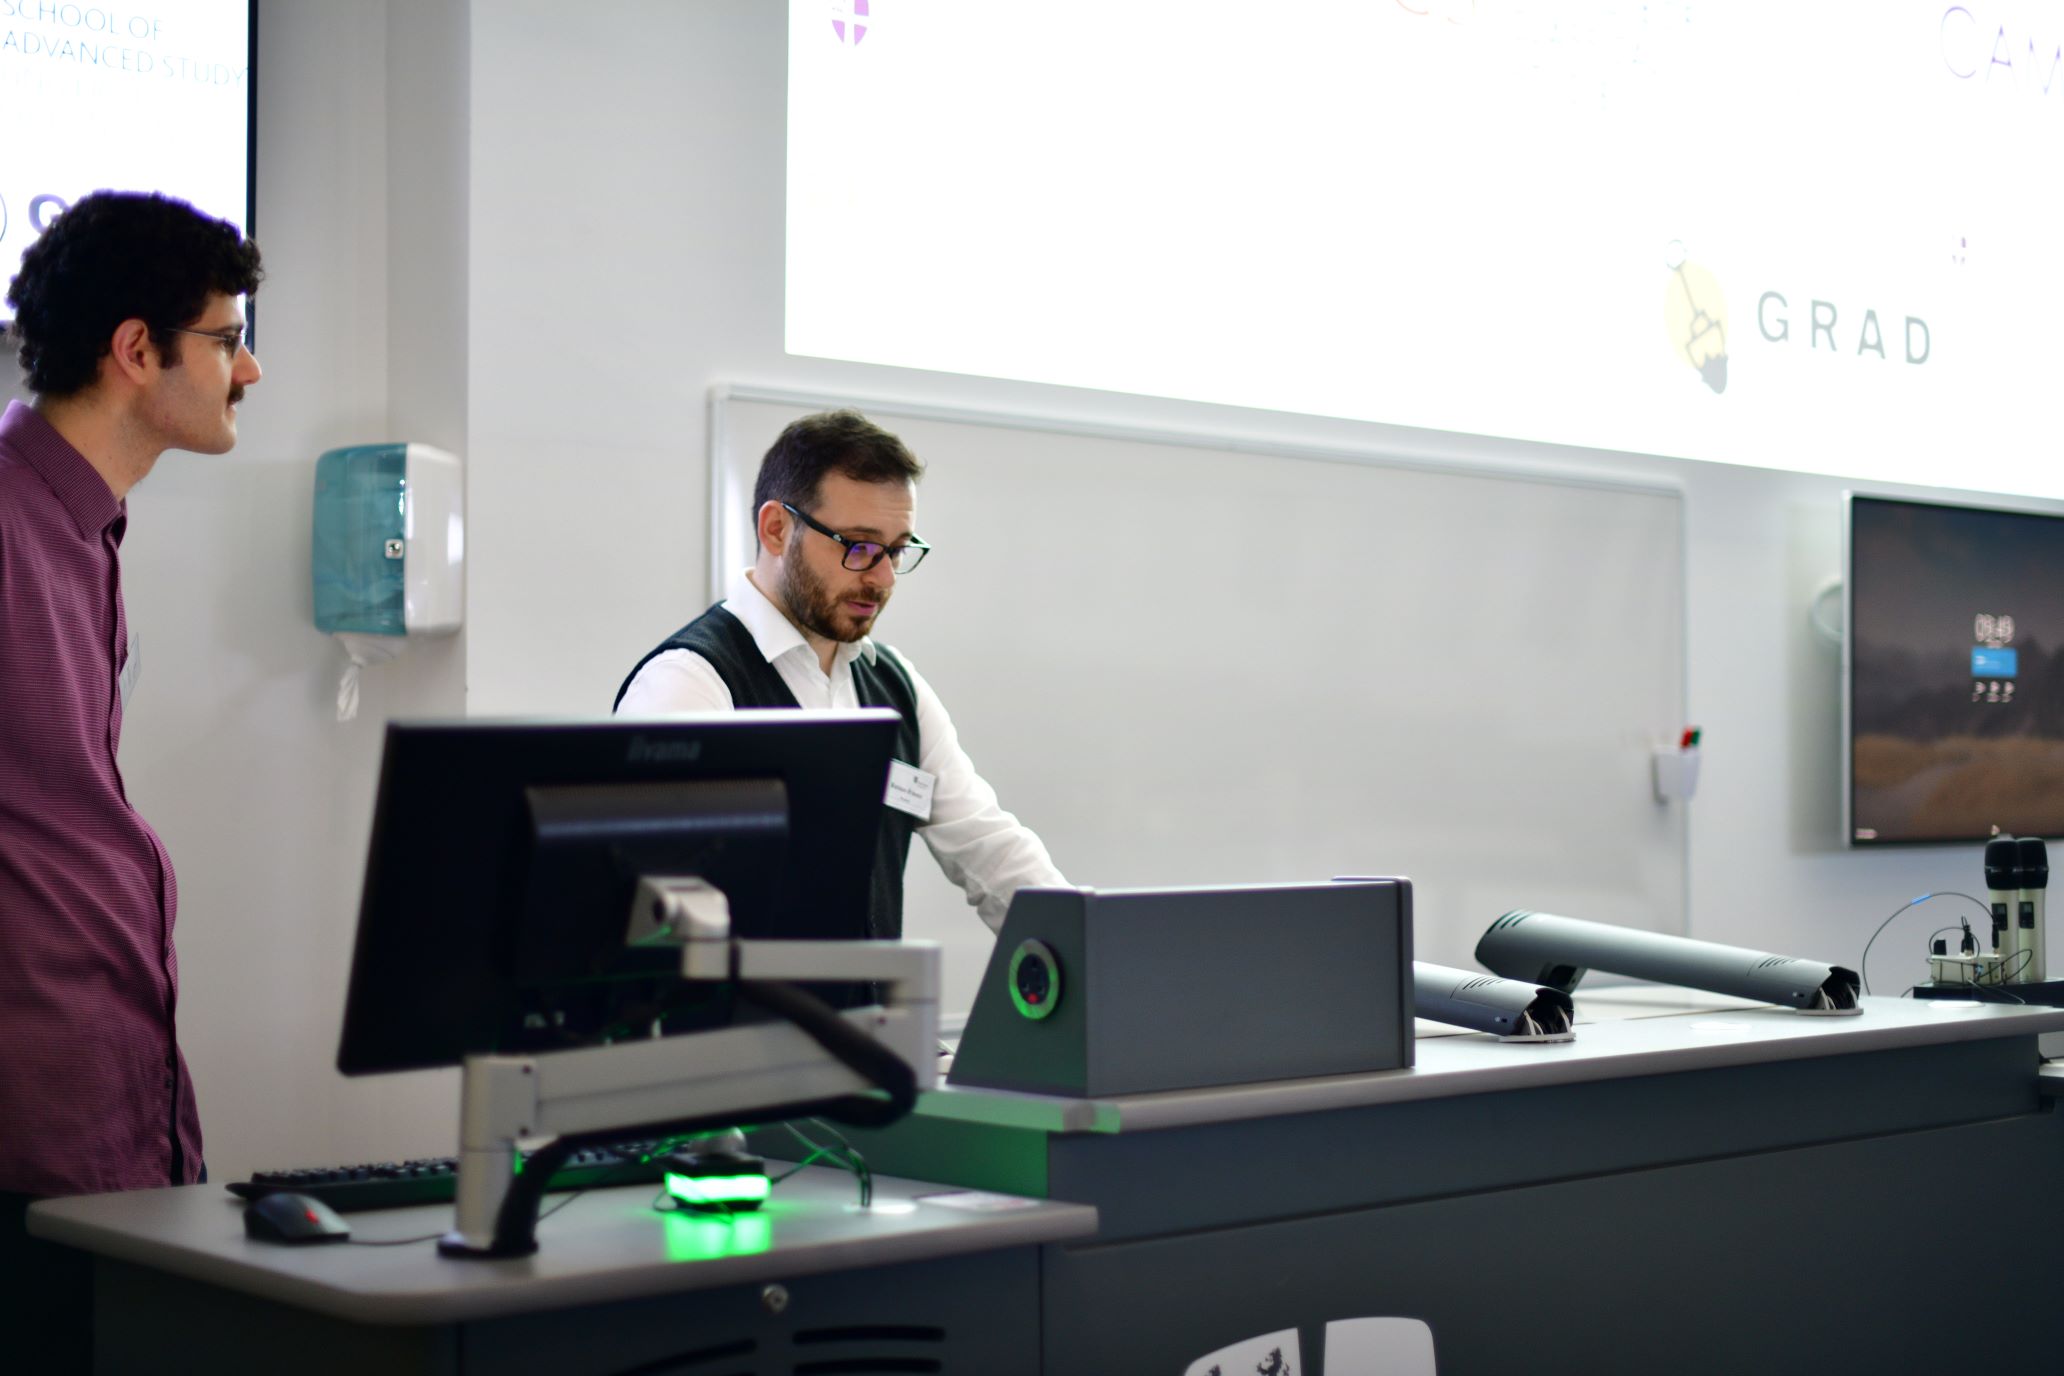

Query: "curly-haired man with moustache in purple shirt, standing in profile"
<box><xmin>0</xmin><ymin>192</ymin><xmax>262</xmax><ymax>1372</ymax></box>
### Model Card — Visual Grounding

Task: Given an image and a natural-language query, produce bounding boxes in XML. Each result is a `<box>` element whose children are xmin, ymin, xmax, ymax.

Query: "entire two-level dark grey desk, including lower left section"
<box><xmin>31</xmin><ymin>992</ymin><xmax>2064</xmax><ymax>1376</ymax></box>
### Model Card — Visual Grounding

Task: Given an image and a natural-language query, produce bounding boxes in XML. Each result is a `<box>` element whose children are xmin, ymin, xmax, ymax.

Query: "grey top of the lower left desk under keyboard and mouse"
<box><xmin>29</xmin><ymin>1168</ymin><xmax>1096</xmax><ymax>1324</ymax></box>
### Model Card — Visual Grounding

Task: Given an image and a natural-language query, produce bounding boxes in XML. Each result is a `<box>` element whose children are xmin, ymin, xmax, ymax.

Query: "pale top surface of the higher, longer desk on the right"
<box><xmin>937</xmin><ymin>986</ymin><xmax>2064</xmax><ymax>1133</ymax></box>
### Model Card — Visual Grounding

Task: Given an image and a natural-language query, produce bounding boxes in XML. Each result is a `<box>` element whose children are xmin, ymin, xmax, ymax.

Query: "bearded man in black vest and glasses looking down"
<box><xmin>617</xmin><ymin>411</ymin><xmax>1067</xmax><ymax>939</ymax></box>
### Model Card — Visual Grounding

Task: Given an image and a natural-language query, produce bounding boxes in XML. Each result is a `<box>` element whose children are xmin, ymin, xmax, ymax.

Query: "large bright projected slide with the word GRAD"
<box><xmin>786</xmin><ymin>0</ymin><xmax>2064</xmax><ymax>495</ymax></box>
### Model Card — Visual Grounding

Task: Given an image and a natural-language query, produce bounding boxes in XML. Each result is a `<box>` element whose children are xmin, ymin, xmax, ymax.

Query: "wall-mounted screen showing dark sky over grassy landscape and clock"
<box><xmin>1841</xmin><ymin>493</ymin><xmax>2064</xmax><ymax>846</ymax></box>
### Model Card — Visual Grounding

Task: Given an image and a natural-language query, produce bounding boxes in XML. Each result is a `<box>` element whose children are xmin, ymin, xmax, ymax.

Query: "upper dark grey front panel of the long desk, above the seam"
<box><xmin>1056</xmin><ymin>1040</ymin><xmax>2039</xmax><ymax>1240</ymax></box>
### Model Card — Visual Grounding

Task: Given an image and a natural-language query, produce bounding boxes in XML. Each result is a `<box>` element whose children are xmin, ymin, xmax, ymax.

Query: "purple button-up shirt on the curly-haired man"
<box><xmin>0</xmin><ymin>402</ymin><xmax>200</xmax><ymax>1194</ymax></box>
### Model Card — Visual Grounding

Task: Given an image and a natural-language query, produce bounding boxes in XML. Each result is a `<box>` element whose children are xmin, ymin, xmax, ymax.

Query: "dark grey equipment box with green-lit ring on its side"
<box><xmin>947</xmin><ymin>879</ymin><xmax>1412</xmax><ymax>1097</ymax></box>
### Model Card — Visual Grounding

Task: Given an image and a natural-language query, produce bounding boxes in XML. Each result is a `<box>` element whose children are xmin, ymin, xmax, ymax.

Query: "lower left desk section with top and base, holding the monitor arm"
<box><xmin>29</xmin><ymin>1168</ymin><xmax>1096</xmax><ymax>1376</ymax></box>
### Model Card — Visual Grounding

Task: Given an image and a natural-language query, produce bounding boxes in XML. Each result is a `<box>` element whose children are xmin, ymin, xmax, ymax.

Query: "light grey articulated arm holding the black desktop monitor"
<box><xmin>440</xmin><ymin>877</ymin><xmax>939</xmax><ymax>1256</ymax></box>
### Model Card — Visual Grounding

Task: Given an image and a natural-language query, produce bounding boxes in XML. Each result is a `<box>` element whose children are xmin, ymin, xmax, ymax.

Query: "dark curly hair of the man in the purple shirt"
<box><xmin>6</xmin><ymin>192</ymin><xmax>264</xmax><ymax>396</ymax></box>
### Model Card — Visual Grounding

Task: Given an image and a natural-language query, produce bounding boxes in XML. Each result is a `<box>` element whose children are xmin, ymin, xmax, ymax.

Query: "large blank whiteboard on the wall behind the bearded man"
<box><xmin>710</xmin><ymin>386</ymin><xmax>1686</xmax><ymax>1009</ymax></box>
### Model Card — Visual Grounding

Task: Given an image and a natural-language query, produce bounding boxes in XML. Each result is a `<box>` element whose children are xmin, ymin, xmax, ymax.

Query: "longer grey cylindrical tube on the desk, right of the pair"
<box><xmin>1476</xmin><ymin>912</ymin><xmax>1864</xmax><ymax>1013</ymax></box>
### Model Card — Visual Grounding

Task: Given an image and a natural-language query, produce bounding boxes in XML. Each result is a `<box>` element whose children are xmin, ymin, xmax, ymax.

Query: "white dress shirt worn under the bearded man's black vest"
<box><xmin>617</xmin><ymin>574</ymin><xmax>1067</xmax><ymax>930</ymax></box>
